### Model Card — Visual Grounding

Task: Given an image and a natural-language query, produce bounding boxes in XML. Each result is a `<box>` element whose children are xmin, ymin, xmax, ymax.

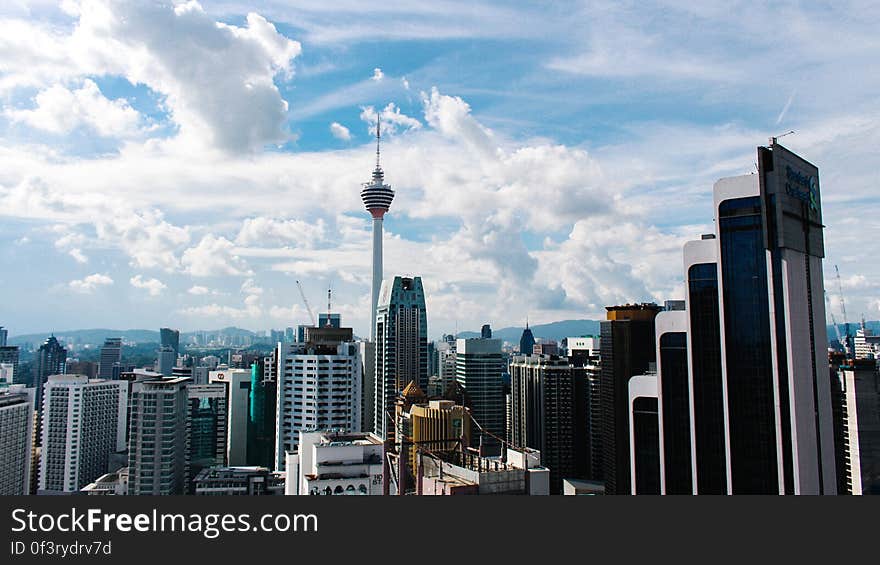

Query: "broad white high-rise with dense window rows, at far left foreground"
<box><xmin>38</xmin><ymin>375</ymin><xmax>128</xmax><ymax>494</ymax></box>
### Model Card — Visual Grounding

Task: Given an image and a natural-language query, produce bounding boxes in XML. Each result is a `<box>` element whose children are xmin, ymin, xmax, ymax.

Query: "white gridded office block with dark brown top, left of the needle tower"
<box><xmin>275</xmin><ymin>327</ymin><xmax>362</xmax><ymax>471</ymax></box>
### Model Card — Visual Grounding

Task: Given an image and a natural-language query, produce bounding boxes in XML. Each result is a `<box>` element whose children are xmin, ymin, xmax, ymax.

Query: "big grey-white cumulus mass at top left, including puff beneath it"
<box><xmin>0</xmin><ymin>0</ymin><xmax>302</xmax><ymax>152</ymax></box>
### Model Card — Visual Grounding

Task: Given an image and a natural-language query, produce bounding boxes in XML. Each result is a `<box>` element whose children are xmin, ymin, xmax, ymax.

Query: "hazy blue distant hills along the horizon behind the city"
<box><xmin>8</xmin><ymin>320</ymin><xmax>880</xmax><ymax>345</ymax></box>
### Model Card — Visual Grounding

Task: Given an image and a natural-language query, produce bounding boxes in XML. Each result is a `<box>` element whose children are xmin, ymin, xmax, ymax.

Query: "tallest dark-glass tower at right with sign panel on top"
<box><xmin>714</xmin><ymin>139</ymin><xmax>837</xmax><ymax>494</ymax></box>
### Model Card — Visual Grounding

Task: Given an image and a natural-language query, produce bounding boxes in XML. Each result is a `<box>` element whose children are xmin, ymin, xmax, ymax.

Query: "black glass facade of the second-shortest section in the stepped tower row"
<box><xmin>660</xmin><ymin>332</ymin><xmax>693</xmax><ymax>494</ymax></box>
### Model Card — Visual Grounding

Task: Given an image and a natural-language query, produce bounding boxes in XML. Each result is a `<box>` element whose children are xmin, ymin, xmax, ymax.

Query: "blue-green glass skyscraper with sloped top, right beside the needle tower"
<box><xmin>373</xmin><ymin>277</ymin><xmax>428</xmax><ymax>439</ymax></box>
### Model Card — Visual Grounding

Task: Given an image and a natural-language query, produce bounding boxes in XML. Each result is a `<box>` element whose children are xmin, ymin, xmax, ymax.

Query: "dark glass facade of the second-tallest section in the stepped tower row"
<box><xmin>688</xmin><ymin>263</ymin><xmax>727</xmax><ymax>494</ymax></box>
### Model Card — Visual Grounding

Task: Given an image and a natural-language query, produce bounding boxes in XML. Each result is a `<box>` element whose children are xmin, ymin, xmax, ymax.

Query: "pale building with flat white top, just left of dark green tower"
<box><xmin>208</xmin><ymin>365</ymin><xmax>253</xmax><ymax>467</ymax></box>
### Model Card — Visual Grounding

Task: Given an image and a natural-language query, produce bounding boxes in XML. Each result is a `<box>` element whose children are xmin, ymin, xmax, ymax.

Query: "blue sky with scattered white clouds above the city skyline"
<box><xmin>0</xmin><ymin>0</ymin><xmax>880</xmax><ymax>336</ymax></box>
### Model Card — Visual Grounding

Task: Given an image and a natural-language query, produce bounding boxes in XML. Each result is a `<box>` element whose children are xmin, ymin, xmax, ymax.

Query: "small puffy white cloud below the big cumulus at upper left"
<box><xmin>5</xmin><ymin>79</ymin><xmax>140</xmax><ymax>137</ymax></box>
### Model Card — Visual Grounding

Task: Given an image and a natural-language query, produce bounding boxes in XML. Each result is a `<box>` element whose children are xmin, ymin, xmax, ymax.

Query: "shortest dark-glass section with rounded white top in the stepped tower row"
<box><xmin>632</xmin><ymin>373</ymin><xmax>661</xmax><ymax>494</ymax></box>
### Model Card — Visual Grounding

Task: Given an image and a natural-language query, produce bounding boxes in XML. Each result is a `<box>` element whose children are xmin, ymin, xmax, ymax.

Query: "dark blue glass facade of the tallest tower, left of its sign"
<box><xmin>718</xmin><ymin>196</ymin><xmax>779</xmax><ymax>494</ymax></box>
